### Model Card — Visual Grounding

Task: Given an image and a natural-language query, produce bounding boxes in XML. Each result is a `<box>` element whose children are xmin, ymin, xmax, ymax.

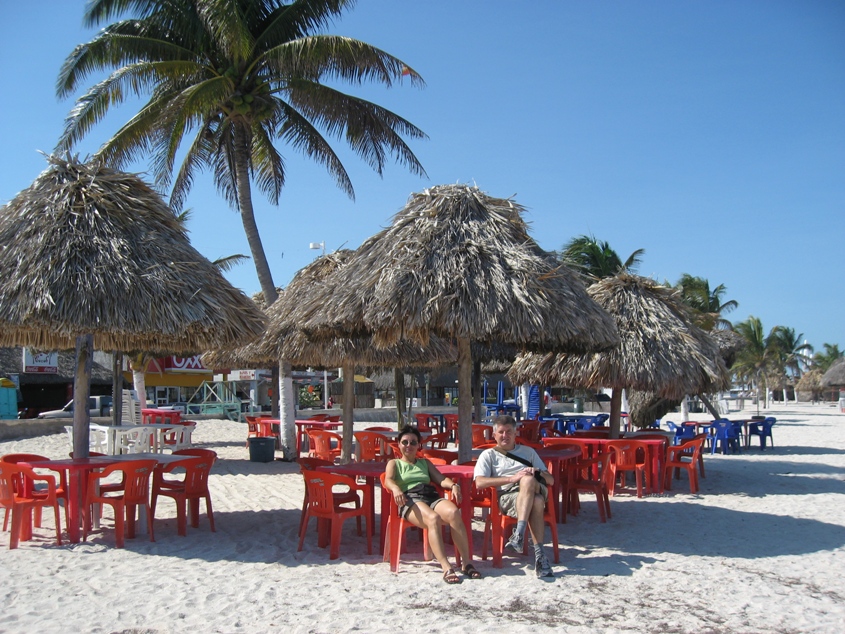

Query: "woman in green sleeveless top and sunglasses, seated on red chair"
<box><xmin>384</xmin><ymin>425</ymin><xmax>481</xmax><ymax>583</ymax></box>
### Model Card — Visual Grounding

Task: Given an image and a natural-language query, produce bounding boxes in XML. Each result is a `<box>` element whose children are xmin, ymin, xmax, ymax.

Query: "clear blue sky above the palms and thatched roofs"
<box><xmin>0</xmin><ymin>0</ymin><xmax>845</xmax><ymax>349</ymax></box>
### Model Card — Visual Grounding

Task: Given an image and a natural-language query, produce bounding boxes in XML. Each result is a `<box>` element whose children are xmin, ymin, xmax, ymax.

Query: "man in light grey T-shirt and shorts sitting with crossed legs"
<box><xmin>473</xmin><ymin>416</ymin><xmax>554</xmax><ymax>578</ymax></box>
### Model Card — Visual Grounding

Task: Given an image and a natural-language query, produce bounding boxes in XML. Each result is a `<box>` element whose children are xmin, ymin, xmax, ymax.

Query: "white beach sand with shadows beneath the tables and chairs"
<box><xmin>0</xmin><ymin>404</ymin><xmax>845</xmax><ymax>633</ymax></box>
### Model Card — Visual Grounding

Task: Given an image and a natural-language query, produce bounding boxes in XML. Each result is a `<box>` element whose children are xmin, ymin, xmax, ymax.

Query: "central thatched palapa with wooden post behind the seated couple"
<box><xmin>286</xmin><ymin>185</ymin><xmax>618</xmax><ymax>460</ymax></box>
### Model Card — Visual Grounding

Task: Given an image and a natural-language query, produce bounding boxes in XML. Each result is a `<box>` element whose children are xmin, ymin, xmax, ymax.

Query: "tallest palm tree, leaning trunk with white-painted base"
<box><xmin>57</xmin><ymin>0</ymin><xmax>425</xmax><ymax>448</ymax></box>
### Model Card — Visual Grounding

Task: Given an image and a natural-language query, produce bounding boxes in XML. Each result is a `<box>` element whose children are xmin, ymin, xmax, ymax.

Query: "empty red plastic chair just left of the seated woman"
<box><xmin>297</xmin><ymin>470</ymin><xmax>373</xmax><ymax>559</ymax></box>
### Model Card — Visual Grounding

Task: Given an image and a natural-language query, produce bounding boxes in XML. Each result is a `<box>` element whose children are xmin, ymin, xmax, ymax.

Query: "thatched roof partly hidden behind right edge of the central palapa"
<box><xmin>509</xmin><ymin>273</ymin><xmax>728</xmax><ymax>398</ymax></box>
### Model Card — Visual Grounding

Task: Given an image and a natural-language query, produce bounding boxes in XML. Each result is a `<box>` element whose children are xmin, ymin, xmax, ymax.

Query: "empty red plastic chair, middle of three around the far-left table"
<box><xmin>82</xmin><ymin>460</ymin><xmax>157</xmax><ymax>548</ymax></box>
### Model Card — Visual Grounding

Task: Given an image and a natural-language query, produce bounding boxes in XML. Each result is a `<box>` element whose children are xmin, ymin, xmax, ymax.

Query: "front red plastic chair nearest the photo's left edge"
<box><xmin>0</xmin><ymin>461</ymin><xmax>62</xmax><ymax>550</ymax></box>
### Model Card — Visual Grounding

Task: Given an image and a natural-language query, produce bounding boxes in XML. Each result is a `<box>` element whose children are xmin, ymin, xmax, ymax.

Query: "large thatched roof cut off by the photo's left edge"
<box><xmin>0</xmin><ymin>157</ymin><xmax>264</xmax><ymax>354</ymax></box>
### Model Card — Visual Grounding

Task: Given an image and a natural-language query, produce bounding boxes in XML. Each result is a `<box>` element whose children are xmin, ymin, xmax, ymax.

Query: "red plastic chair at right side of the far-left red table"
<box><xmin>150</xmin><ymin>456</ymin><xmax>215</xmax><ymax>537</ymax></box>
